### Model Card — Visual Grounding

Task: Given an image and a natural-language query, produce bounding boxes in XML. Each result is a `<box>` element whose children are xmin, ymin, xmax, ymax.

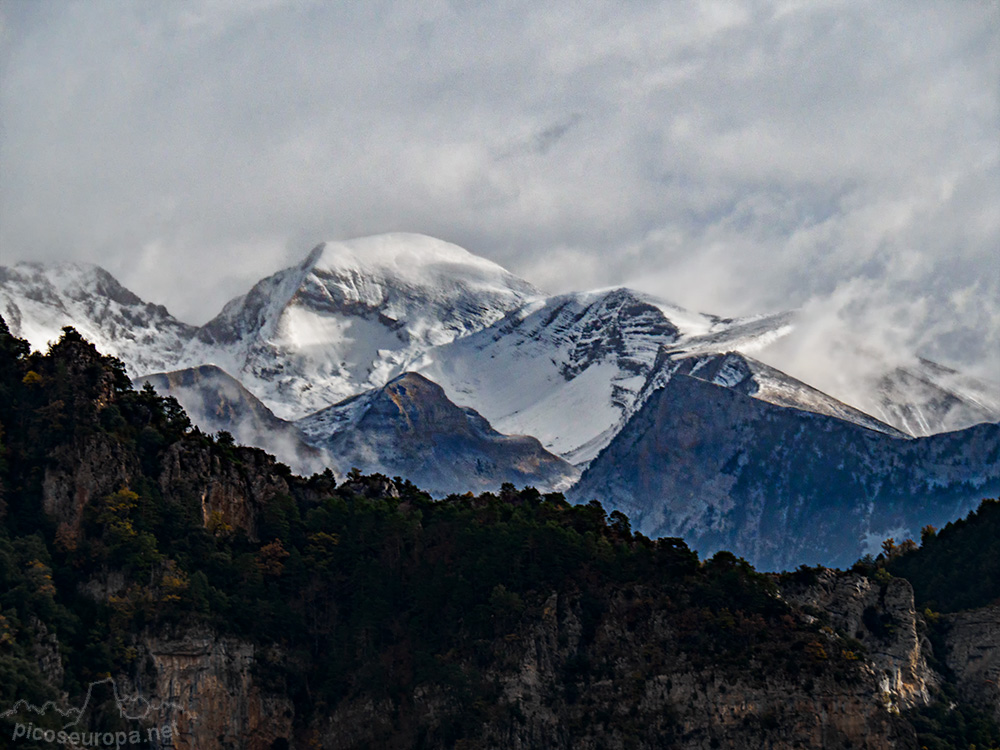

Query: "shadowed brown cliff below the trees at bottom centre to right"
<box><xmin>478</xmin><ymin>592</ymin><xmax>912</xmax><ymax>750</ymax></box>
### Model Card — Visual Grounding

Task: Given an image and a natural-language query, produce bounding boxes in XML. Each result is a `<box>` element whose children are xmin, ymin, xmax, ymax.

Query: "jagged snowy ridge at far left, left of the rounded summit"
<box><xmin>0</xmin><ymin>263</ymin><xmax>196</xmax><ymax>376</ymax></box>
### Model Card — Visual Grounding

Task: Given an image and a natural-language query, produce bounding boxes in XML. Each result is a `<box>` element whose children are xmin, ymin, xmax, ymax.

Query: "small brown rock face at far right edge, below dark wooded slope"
<box><xmin>945</xmin><ymin>606</ymin><xmax>1000</xmax><ymax>720</ymax></box>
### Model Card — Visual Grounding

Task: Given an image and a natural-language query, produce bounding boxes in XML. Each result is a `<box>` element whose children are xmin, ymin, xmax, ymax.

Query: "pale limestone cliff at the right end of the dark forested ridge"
<box><xmin>783</xmin><ymin>569</ymin><xmax>941</xmax><ymax>709</ymax></box>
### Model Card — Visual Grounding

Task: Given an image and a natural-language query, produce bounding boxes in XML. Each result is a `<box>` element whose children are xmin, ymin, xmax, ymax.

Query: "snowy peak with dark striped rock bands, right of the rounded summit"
<box><xmin>414</xmin><ymin>288</ymin><xmax>800</xmax><ymax>465</ymax></box>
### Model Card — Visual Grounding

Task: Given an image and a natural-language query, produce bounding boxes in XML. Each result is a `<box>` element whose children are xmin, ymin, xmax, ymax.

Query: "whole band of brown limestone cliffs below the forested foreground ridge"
<box><xmin>25</xmin><ymin>573</ymin><xmax>928</xmax><ymax>750</ymax></box>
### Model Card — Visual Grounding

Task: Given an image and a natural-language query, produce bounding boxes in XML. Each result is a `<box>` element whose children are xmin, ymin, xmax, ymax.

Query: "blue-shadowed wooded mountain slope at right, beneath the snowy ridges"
<box><xmin>568</xmin><ymin>373</ymin><xmax>1000</xmax><ymax>570</ymax></box>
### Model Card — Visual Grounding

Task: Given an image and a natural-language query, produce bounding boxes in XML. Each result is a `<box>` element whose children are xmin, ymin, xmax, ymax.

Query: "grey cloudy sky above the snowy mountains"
<box><xmin>0</xmin><ymin>0</ymin><xmax>1000</xmax><ymax>382</ymax></box>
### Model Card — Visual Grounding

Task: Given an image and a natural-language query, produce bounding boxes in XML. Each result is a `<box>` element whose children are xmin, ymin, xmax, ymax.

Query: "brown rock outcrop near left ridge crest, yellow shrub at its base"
<box><xmin>160</xmin><ymin>442</ymin><xmax>290</xmax><ymax>541</ymax></box>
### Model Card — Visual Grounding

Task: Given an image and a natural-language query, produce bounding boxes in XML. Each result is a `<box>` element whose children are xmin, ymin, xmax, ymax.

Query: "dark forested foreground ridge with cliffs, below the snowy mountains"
<box><xmin>0</xmin><ymin>323</ymin><xmax>1000</xmax><ymax>750</ymax></box>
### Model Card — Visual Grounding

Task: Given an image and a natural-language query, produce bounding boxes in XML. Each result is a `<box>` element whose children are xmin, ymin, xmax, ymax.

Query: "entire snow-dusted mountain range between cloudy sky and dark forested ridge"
<box><xmin>0</xmin><ymin>234</ymin><xmax>1000</xmax><ymax>567</ymax></box>
